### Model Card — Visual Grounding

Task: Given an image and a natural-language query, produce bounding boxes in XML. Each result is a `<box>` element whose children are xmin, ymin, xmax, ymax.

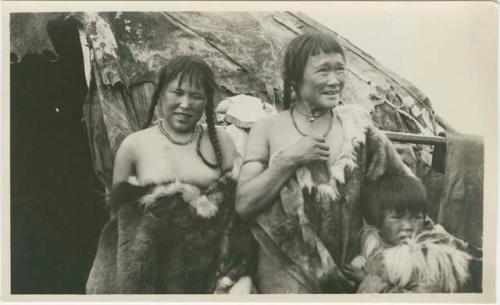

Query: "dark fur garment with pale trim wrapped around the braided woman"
<box><xmin>86</xmin><ymin>176</ymin><xmax>256</xmax><ymax>294</ymax></box>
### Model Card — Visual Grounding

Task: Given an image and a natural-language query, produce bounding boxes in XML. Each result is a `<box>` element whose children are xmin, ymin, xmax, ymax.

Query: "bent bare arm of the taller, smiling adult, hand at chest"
<box><xmin>236</xmin><ymin>119</ymin><xmax>329</xmax><ymax>219</ymax></box>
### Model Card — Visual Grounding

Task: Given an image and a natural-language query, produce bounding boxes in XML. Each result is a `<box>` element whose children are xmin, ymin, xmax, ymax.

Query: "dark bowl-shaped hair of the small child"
<box><xmin>362</xmin><ymin>174</ymin><xmax>428</xmax><ymax>227</ymax></box>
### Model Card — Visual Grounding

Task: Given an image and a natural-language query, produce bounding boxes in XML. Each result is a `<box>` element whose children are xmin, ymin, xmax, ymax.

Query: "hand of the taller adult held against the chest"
<box><xmin>275</xmin><ymin>137</ymin><xmax>330</xmax><ymax>167</ymax></box>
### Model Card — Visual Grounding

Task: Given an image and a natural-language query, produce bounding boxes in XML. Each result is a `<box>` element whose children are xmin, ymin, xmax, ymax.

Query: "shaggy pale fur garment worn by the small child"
<box><xmin>354</xmin><ymin>225</ymin><xmax>471</xmax><ymax>293</ymax></box>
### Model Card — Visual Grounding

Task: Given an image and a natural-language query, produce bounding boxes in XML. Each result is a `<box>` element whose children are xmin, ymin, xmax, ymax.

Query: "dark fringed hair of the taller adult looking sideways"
<box><xmin>282</xmin><ymin>33</ymin><xmax>345</xmax><ymax>109</ymax></box>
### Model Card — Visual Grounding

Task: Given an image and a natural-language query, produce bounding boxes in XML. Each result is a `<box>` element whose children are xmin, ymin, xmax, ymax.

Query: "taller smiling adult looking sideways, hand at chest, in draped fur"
<box><xmin>236</xmin><ymin>34</ymin><xmax>412</xmax><ymax>293</ymax></box>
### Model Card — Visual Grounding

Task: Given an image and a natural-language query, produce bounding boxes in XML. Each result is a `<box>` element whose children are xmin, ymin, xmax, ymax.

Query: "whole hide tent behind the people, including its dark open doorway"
<box><xmin>10</xmin><ymin>11</ymin><xmax>482</xmax><ymax>292</ymax></box>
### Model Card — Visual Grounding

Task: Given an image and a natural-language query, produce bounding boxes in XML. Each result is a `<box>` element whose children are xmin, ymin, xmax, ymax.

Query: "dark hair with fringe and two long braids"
<box><xmin>143</xmin><ymin>55</ymin><xmax>223</xmax><ymax>171</ymax></box>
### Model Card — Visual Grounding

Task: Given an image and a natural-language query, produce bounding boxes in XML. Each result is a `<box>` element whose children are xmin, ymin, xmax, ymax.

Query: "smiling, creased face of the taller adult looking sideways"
<box><xmin>299</xmin><ymin>52</ymin><xmax>345</xmax><ymax>109</ymax></box>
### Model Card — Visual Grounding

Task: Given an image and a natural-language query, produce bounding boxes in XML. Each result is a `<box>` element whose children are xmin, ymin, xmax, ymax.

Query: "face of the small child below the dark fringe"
<box><xmin>380</xmin><ymin>210</ymin><xmax>424</xmax><ymax>246</ymax></box>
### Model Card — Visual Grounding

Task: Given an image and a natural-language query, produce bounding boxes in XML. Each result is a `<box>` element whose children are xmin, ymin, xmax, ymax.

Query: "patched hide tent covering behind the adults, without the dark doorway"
<box><xmin>11</xmin><ymin>12</ymin><xmax>449</xmax><ymax>186</ymax></box>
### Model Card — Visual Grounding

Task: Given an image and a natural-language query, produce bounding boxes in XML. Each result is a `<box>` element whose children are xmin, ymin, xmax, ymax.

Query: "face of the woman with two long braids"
<box><xmin>160</xmin><ymin>76</ymin><xmax>207</xmax><ymax>133</ymax></box>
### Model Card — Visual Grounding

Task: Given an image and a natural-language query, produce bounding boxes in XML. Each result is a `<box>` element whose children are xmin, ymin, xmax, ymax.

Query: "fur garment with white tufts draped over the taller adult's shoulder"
<box><xmin>252</xmin><ymin>105</ymin><xmax>413</xmax><ymax>293</ymax></box>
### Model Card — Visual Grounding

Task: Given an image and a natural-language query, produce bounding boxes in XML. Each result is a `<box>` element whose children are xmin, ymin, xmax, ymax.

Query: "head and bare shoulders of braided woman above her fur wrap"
<box><xmin>113</xmin><ymin>56</ymin><xmax>229</xmax><ymax>187</ymax></box>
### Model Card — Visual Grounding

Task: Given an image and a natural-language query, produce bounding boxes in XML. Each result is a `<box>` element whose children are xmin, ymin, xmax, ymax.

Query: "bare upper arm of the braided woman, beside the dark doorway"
<box><xmin>113</xmin><ymin>135</ymin><xmax>135</xmax><ymax>186</ymax></box>
